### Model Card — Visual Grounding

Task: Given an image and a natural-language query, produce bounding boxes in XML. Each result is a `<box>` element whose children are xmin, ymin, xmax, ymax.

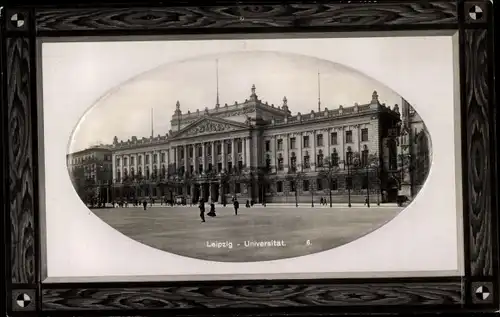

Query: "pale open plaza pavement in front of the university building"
<box><xmin>93</xmin><ymin>204</ymin><xmax>404</xmax><ymax>262</ymax></box>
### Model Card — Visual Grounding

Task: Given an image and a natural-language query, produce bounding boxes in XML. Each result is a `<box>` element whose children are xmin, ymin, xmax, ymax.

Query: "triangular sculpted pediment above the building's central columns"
<box><xmin>175</xmin><ymin>116</ymin><xmax>248</xmax><ymax>138</ymax></box>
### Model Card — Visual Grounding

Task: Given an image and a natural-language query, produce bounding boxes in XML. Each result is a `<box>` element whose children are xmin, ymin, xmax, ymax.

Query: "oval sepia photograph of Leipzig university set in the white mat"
<box><xmin>67</xmin><ymin>50</ymin><xmax>432</xmax><ymax>262</ymax></box>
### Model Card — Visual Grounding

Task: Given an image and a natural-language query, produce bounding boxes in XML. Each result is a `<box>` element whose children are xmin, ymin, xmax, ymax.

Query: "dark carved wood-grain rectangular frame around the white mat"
<box><xmin>0</xmin><ymin>0</ymin><xmax>500</xmax><ymax>315</ymax></box>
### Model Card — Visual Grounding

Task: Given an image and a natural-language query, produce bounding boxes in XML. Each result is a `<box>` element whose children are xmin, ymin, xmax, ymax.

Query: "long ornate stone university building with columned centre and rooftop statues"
<box><xmin>107</xmin><ymin>86</ymin><xmax>430</xmax><ymax>203</ymax></box>
